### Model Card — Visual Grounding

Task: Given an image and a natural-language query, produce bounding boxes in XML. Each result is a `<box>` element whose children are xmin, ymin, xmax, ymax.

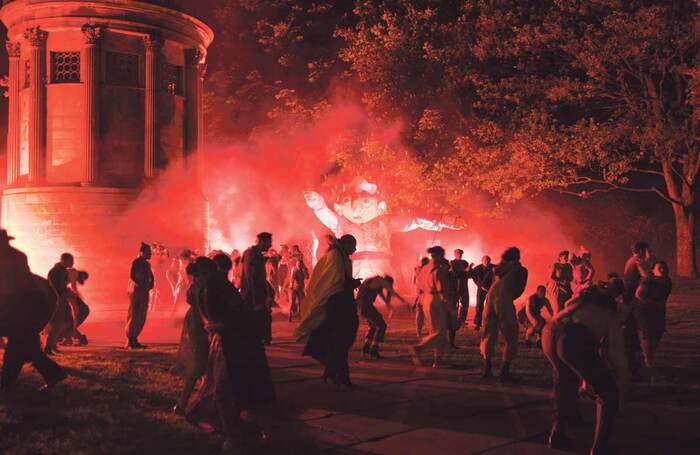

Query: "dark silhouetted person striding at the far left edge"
<box><xmin>0</xmin><ymin>229</ymin><xmax>66</xmax><ymax>390</ymax></box>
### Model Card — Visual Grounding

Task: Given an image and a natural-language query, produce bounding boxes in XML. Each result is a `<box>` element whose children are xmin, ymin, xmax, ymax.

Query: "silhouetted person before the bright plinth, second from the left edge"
<box><xmin>44</xmin><ymin>253</ymin><xmax>75</xmax><ymax>355</ymax></box>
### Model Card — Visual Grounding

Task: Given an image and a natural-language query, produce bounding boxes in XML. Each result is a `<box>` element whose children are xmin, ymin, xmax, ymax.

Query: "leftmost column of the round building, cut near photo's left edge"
<box><xmin>5</xmin><ymin>41</ymin><xmax>21</xmax><ymax>186</ymax></box>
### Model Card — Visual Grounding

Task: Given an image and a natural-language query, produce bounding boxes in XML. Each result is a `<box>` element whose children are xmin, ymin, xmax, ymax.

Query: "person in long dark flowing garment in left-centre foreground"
<box><xmin>186</xmin><ymin>258</ymin><xmax>275</xmax><ymax>446</ymax></box>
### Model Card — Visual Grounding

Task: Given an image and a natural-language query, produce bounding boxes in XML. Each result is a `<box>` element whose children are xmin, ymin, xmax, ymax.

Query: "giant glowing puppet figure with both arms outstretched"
<box><xmin>304</xmin><ymin>179</ymin><xmax>458</xmax><ymax>278</ymax></box>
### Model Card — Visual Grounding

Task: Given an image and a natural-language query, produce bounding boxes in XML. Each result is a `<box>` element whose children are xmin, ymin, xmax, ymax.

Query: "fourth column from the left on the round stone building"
<box><xmin>143</xmin><ymin>34</ymin><xmax>163</xmax><ymax>178</ymax></box>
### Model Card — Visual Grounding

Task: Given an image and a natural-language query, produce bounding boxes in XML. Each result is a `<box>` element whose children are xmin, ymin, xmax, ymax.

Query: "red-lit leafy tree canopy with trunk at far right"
<box><xmin>205</xmin><ymin>0</ymin><xmax>700</xmax><ymax>276</ymax></box>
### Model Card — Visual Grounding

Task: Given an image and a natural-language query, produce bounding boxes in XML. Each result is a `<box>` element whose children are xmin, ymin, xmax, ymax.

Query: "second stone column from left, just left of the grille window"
<box><xmin>24</xmin><ymin>27</ymin><xmax>48</xmax><ymax>185</ymax></box>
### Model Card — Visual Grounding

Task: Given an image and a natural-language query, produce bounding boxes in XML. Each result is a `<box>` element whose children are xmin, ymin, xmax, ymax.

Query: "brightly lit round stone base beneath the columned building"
<box><xmin>2</xmin><ymin>187</ymin><xmax>138</xmax><ymax>319</ymax></box>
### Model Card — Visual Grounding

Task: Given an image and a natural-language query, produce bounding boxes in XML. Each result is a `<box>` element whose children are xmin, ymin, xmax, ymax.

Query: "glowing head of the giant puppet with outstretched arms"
<box><xmin>333</xmin><ymin>179</ymin><xmax>387</xmax><ymax>224</ymax></box>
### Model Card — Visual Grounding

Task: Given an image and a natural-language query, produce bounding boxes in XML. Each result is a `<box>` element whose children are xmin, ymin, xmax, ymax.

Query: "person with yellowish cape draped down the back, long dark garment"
<box><xmin>294</xmin><ymin>235</ymin><xmax>360</xmax><ymax>387</ymax></box>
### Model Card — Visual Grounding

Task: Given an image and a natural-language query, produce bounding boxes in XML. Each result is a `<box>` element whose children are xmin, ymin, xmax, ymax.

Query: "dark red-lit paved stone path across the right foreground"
<box><xmin>258</xmin><ymin>334</ymin><xmax>700</xmax><ymax>454</ymax></box>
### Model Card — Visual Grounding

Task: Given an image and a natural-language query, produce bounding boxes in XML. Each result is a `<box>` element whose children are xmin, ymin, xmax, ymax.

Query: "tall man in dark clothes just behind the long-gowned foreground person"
<box><xmin>240</xmin><ymin>232</ymin><xmax>274</xmax><ymax>344</ymax></box>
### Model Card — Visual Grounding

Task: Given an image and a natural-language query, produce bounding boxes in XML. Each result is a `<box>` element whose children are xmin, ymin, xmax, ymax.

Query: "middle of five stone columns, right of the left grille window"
<box><xmin>80</xmin><ymin>24</ymin><xmax>102</xmax><ymax>185</ymax></box>
